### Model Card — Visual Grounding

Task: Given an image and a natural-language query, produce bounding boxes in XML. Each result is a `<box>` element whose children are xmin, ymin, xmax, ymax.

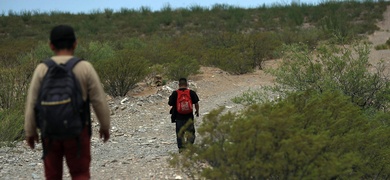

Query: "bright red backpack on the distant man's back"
<box><xmin>176</xmin><ymin>89</ymin><xmax>192</xmax><ymax>114</ymax></box>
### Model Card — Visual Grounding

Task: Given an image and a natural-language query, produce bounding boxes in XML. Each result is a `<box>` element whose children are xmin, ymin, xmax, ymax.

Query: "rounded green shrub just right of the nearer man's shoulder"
<box><xmin>97</xmin><ymin>49</ymin><xmax>149</xmax><ymax>96</ymax></box>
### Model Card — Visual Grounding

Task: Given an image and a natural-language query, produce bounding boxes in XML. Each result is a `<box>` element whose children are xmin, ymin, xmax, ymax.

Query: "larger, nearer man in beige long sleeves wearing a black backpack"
<box><xmin>24</xmin><ymin>25</ymin><xmax>110</xmax><ymax>179</ymax></box>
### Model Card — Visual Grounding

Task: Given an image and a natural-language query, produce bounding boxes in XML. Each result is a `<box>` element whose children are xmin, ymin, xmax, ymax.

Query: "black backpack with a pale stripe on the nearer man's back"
<box><xmin>35</xmin><ymin>58</ymin><xmax>89</xmax><ymax>141</ymax></box>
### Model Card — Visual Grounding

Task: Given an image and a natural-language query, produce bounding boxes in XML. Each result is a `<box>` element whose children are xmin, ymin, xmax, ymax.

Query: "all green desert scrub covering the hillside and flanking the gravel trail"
<box><xmin>0</xmin><ymin>1</ymin><xmax>390</xmax><ymax>179</ymax></box>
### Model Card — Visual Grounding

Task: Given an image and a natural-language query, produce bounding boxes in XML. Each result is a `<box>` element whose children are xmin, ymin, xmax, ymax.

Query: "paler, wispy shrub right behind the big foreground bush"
<box><xmin>267</xmin><ymin>44</ymin><xmax>390</xmax><ymax>110</ymax></box>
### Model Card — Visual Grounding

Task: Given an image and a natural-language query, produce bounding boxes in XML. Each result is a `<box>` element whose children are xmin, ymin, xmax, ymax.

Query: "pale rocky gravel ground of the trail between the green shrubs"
<box><xmin>0</xmin><ymin>5</ymin><xmax>390</xmax><ymax>180</ymax></box>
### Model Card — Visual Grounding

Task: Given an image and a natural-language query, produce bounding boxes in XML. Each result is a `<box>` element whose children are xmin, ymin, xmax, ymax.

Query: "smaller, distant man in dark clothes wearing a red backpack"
<box><xmin>168</xmin><ymin>78</ymin><xmax>199</xmax><ymax>152</ymax></box>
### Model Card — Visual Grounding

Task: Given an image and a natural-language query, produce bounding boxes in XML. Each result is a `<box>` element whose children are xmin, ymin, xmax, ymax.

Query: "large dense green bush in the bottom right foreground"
<box><xmin>170</xmin><ymin>91</ymin><xmax>390</xmax><ymax>179</ymax></box>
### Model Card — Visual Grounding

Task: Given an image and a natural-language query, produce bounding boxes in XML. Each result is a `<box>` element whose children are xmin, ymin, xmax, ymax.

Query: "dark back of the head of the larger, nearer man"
<box><xmin>50</xmin><ymin>25</ymin><xmax>76</xmax><ymax>50</ymax></box>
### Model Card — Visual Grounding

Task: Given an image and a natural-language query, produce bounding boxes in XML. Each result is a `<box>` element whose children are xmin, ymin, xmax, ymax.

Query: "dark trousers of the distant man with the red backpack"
<box><xmin>176</xmin><ymin>119</ymin><xmax>195</xmax><ymax>149</ymax></box>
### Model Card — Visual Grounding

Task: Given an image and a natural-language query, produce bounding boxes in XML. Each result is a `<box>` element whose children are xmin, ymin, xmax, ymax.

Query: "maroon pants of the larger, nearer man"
<box><xmin>43</xmin><ymin>128</ymin><xmax>91</xmax><ymax>180</ymax></box>
